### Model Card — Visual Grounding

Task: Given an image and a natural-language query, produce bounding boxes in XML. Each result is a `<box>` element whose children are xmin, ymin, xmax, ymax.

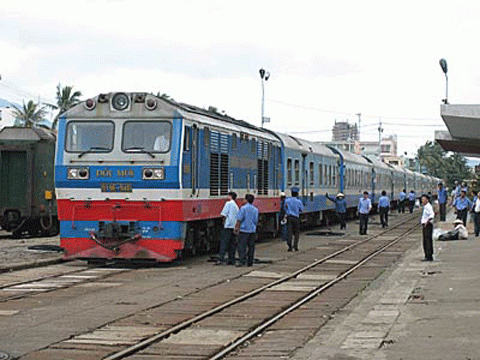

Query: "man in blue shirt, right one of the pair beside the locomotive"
<box><xmin>234</xmin><ymin>194</ymin><xmax>258</xmax><ymax>266</ymax></box>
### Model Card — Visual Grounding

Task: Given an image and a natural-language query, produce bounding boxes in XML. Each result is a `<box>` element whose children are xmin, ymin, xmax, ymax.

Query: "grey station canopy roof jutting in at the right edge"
<box><xmin>435</xmin><ymin>104</ymin><xmax>480</xmax><ymax>156</ymax></box>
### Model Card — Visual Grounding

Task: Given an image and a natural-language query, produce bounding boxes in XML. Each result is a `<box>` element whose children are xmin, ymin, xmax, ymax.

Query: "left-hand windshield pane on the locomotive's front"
<box><xmin>65</xmin><ymin>121</ymin><xmax>115</xmax><ymax>153</ymax></box>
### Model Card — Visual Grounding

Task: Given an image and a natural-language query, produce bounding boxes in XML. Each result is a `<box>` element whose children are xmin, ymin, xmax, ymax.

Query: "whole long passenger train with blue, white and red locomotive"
<box><xmin>55</xmin><ymin>93</ymin><xmax>437</xmax><ymax>261</ymax></box>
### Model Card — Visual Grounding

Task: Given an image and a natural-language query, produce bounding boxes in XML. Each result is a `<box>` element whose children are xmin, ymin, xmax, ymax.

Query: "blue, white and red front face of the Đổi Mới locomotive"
<box><xmin>55</xmin><ymin>93</ymin><xmax>185</xmax><ymax>261</ymax></box>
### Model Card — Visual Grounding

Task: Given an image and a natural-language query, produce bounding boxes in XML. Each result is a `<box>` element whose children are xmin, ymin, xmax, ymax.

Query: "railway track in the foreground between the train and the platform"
<box><xmin>15</xmin><ymin>212</ymin><xmax>418</xmax><ymax>360</ymax></box>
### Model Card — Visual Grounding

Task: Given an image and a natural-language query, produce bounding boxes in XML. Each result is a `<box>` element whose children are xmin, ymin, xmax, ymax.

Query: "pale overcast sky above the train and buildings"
<box><xmin>0</xmin><ymin>0</ymin><xmax>480</xmax><ymax>155</ymax></box>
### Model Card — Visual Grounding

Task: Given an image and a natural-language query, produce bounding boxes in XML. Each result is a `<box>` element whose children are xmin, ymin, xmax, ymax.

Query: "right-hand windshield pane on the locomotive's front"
<box><xmin>122</xmin><ymin>121</ymin><xmax>172</xmax><ymax>153</ymax></box>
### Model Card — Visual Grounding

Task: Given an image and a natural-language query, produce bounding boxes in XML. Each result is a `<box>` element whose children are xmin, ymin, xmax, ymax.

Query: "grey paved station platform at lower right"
<box><xmin>290</xmin><ymin>214</ymin><xmax>480</xmax><ymax>360</ymax></box>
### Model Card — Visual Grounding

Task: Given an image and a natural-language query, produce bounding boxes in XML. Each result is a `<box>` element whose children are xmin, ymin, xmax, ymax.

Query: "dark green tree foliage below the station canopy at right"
<box><xmin>417</xmin><ymin>141</ymin><xmax>472</xmax><ymax>188</ymax></box>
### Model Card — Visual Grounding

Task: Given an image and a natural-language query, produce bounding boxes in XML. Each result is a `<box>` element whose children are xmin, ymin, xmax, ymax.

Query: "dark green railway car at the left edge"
<box><xmin>0</xmin><ymin>127</ymin><xmax>58</xmax><ymax>237</ymax></box>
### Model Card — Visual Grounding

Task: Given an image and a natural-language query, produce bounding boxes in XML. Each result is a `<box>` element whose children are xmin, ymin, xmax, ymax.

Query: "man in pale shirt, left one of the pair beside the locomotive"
<box><xmin>215</xmin><ymin>191</ymin><xmax>238</xmax><ymax>265</ymax></box>
